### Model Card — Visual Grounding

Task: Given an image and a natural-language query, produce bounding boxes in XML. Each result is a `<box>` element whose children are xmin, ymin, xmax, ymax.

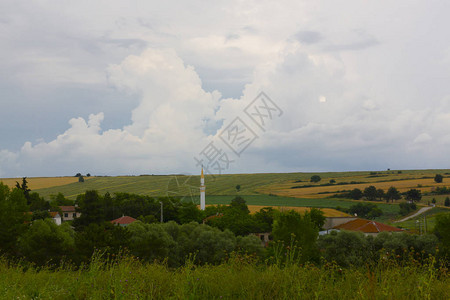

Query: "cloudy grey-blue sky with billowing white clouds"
<box><xmin>0</xmin><ymin>0</ymin><xmax>450</xmax><ymax>178</ymax></box>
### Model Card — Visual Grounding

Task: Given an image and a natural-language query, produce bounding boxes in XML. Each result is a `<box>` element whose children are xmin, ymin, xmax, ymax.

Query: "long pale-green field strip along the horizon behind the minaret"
<box><xmin>30</xmin><ymin>170</ymin><xmax>450</xmax><ymax>199</ymax></box>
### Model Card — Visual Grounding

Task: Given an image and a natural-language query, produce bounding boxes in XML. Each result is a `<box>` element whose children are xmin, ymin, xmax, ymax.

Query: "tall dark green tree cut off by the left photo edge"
<box><xmin>0</xmin><ymin>182</ymin><xmax>30</xmax><ymax>254</ymax></box>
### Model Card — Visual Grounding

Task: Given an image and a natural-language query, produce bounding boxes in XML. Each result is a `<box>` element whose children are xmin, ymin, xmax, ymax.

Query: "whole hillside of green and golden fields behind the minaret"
<box><xmin>0</xmin><ymin>169</ymin><xmax>450</xmax><ymax>226</ymax></box>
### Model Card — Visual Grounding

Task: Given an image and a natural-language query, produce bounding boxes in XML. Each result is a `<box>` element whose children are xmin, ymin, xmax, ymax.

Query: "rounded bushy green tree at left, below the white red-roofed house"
<box><xmin>19</xmin><ymin>219</ymin><xmax>75</xmax><ymax>265</ymax></box>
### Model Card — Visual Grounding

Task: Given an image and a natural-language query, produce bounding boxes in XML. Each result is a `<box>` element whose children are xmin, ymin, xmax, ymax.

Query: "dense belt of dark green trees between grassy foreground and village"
<box><xmin>0</xmin><ymin>183</ymin><xmax>450</xmax><ymax>266</ymax></box>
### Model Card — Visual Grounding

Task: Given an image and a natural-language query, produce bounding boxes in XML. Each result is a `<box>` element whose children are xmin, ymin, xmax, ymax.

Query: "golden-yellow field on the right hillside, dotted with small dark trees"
<box><xmin>258</xmin><ymin>178</ymin><xmax>446</xmax><ymax>198</ymax></box>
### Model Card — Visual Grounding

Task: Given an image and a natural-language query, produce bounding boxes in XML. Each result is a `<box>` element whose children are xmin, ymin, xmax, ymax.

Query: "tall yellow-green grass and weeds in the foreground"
<box><xmin>0</xmin><ymin>253</ymin><xmax>450</xmax><ymax>299</ymax></box>
